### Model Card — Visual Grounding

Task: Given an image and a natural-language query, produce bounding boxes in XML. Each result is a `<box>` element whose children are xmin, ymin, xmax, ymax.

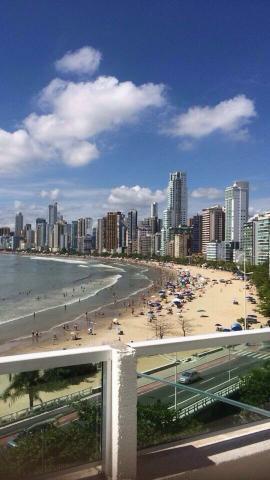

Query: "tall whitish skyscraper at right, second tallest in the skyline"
<box><xmin>225</xmin><ymin>181</ymin><xmax>249</xmax><ymax>247</ymax></box>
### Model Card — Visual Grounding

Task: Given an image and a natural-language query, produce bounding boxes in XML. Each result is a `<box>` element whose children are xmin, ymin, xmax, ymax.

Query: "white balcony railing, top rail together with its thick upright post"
<box><xmin>0</xmin><ymin>328</ymin><xmax>270</xmax><ymax>480</ymax></box>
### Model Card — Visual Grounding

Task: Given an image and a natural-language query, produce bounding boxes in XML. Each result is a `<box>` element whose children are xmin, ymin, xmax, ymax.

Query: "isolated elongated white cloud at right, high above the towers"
<box><xmin>168</xmin><ymin>95</ymin><xmax>256</xmax><ymax>140</ymax></box>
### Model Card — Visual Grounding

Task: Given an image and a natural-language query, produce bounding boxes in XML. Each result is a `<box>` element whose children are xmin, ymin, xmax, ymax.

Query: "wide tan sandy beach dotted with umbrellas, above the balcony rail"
<box><xmin>3</xmin><ymin>260</ymin><xmax>266</xmax><ymax>354</ymax></box>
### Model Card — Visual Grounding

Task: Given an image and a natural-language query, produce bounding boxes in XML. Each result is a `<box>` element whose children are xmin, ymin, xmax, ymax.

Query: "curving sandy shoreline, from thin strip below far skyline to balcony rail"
<box><xmin>0</xmin><ymin>255</ymin><xmax>266</xmax><ymax>354</ymax></box>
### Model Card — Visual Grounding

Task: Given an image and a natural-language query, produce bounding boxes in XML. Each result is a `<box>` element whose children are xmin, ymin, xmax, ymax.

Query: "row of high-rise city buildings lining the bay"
<box><xmin>0</xmin><ymin>171</ymin><xmax>256</xmax><ymax>262</ymax></box>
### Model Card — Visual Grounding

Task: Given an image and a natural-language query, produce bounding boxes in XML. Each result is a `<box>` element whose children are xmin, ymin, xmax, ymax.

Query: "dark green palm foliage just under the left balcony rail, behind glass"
<box><xmin>1</xmin><ymin>363</ymin><xmax>97</xmax><ymax>408</ymax></box>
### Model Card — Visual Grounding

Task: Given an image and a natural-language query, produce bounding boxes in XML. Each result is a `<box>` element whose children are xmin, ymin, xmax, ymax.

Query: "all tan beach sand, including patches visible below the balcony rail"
<box><xmin>0</xmin><ymin>262</ymin><xmax>266</xmax><ymax>416</ymax></box>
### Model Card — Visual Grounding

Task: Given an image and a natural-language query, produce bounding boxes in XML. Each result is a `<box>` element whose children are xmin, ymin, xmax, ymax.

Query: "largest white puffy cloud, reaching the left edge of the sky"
<box><xmin>0</xmin><ymin>46</ymin><xmax>165</xmax><ymax>173</ymax></box>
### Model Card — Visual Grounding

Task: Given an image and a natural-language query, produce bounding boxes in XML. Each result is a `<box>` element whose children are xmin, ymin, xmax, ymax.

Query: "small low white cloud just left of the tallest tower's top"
<box><xmin>108</xmin><ymin>185</ymin><xmax>166</xmax><ymax>207</ymax></box>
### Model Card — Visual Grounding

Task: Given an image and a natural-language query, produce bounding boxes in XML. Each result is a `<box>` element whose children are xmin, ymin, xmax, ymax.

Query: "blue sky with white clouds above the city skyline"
<box><xmin>0</xmin><ymin>0</ymin><xmax>270</xmax><ymax>225</ymax></box>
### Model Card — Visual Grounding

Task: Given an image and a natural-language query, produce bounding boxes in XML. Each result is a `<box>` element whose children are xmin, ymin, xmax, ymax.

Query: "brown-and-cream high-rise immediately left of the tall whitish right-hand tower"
<box><xmin>202</xmin><ymin>205</ymin><xmax>225</xmax><ymax>254</ymax></box>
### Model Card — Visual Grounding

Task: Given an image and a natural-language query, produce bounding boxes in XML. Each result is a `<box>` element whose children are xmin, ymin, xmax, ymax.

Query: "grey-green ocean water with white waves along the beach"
<box><xmin>0</xmin><ymin>254</ymin><xmax>154</xmax><ymax>343</ymax></box>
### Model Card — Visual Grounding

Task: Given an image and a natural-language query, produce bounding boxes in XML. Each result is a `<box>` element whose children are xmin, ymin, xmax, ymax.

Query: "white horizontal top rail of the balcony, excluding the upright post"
<box><xmin>0</xmin><ymin>328</ymin><xmax>270</xmax><ymax>375</ymax></box>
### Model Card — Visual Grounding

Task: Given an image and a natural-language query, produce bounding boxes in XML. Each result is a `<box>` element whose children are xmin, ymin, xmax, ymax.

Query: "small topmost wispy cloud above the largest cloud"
<box><xmin>55</xmin><ymin>46</ymin><xmax>102</xmax><ymax>75</ymax></box>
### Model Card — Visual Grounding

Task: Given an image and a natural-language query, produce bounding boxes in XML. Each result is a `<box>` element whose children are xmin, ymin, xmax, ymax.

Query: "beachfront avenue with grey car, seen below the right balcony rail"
<box><xmin>138</xmin><ymin>345</ymin><xmax>270</xmax><ymax>410</ymax></box>
